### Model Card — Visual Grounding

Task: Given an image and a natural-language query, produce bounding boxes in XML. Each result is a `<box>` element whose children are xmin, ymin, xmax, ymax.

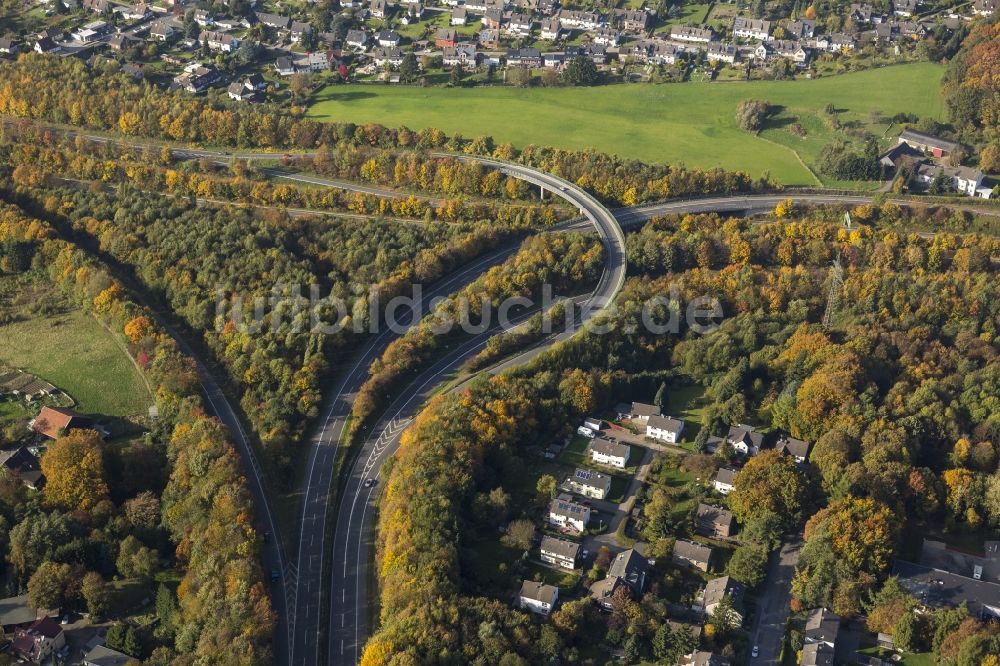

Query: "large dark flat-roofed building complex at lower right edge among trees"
<box><xmin>892</xmin><ymin>539</ymin><xmax>1000</xmax><ymax>620</ymax></box>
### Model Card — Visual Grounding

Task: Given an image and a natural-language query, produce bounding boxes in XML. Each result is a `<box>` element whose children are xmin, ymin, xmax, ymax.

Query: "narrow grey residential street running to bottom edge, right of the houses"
<box><xmin>752</xmin><ymin>534</ymin><xmax>802</xmax><ymax>664</ymax></box>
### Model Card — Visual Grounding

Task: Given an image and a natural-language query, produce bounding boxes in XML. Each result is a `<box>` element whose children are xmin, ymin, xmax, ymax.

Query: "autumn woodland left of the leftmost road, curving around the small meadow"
<box><xmin>0</xmin><ymin>204</ymin><xmax>275</xmax><ymax>666</ymax></box>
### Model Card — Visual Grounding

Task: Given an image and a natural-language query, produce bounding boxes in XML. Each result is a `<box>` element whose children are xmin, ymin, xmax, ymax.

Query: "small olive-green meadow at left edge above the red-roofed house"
<box><xmin>0</xmin><ymin>311</ymin><xmax>152</xmax><ymax>416</ymax></box>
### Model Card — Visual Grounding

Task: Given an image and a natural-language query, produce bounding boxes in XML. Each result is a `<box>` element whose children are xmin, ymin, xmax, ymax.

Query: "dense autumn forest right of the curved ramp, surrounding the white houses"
<box><xmin>363</xmin><ymin>205</ymin><xmax>1000</xmax><ymax>665</ymax></box>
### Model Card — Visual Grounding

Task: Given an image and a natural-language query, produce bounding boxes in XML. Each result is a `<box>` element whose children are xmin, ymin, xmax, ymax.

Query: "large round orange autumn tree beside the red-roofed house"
<box><xmin>41</xmin><ymin>430</ymin><xmax>108</xmax><ymax>511</ymax></box>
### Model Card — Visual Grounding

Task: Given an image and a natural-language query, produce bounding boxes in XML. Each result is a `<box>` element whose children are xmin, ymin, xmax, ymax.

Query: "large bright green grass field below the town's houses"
<box><xmin>310</xmin><ymin>63</ymin><xmax>944</xmax><ymax>185</ymax></box>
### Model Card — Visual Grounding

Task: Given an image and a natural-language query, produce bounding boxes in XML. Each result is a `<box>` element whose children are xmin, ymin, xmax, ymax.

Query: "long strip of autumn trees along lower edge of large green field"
<box><xmin>0</xmin><ymin>53</ymin><xmax>756</xmax><ymax>206</ymax></box>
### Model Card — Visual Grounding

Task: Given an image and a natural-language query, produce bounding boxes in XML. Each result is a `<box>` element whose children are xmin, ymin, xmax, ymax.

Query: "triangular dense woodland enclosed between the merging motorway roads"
<box><xmin>0</xmin><ymin>179</ymin><xmax>517</xmax><ymax>472</ymax></box>
